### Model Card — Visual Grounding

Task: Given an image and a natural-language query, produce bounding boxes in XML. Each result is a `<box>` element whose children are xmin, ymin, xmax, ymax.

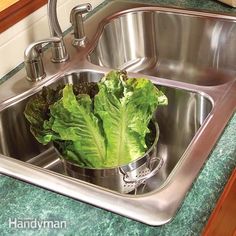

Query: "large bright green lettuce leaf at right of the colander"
<box><xmin>94</xmin><ymin>71</ymin><xmax>167</xmax><ymax>166</ymax></box>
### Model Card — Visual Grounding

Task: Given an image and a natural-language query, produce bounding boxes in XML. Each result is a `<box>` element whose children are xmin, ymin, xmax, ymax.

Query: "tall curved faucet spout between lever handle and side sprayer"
<box><xmin>47</xmin><ymin>0</ymin><xmax>69</xmax><ymax>63</ymax></box>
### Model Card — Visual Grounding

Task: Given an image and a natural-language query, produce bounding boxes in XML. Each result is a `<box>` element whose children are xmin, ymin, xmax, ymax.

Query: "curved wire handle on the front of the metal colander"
<box><xmin>121</xmin><ymin>157</ymin><xmax>164</xmax><ymax>183</ymax></box>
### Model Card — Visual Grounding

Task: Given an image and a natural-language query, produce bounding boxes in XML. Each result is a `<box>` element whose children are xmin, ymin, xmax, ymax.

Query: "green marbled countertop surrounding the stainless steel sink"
<box><xmin>0</xmin><ymin>0</ymin><xmax>236</xmax><ymax>236</ymax></box>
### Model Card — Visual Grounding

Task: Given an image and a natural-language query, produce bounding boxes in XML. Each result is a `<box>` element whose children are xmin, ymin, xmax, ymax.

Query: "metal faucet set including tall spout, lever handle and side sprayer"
<box><xmin>24</xmin><ymin>0</ymin><xmax>92</xmax><ymax>82</ymax></box>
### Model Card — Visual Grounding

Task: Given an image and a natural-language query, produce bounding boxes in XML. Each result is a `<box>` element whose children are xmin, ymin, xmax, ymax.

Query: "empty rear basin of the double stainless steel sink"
<box><xmin>89</xmin><ymin>10</ymin><xmax>236</xmax><ymax>85</ymax></box>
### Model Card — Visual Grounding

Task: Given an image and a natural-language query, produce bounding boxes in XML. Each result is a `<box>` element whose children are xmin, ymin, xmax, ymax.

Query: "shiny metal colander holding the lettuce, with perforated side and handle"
<box><xmin>56</xmin><ymin>122</ymin><xmax>163</xmax><ymax>193</ymax></box>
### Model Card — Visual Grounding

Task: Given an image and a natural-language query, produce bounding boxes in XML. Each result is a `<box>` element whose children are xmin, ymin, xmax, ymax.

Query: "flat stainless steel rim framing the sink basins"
<box><xmin>0</xmin><ymin>2</ymin><xmax>236</xmax><ymax>226</ymax></box>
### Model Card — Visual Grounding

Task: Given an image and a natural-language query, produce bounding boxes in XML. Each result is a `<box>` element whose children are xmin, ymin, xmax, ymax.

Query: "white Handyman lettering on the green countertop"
<box><xmin>8</xmin><ymin>218</ymin><xmax>67</xmax><ymax>229</ymax></box>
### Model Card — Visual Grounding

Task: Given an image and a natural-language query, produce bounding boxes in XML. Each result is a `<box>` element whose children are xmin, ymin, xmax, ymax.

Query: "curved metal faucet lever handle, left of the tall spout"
<box><xmin>24</xmin><ymin>37</ymin><xmax>61</xmax><ymax>82</ymax></box>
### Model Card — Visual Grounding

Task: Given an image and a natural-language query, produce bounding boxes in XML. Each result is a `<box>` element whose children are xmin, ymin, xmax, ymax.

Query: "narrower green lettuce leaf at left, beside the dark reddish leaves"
<box><xmin>47</xmin><ymin>85</ymin><xmax>106</xmax><ymax>167</ymax></box>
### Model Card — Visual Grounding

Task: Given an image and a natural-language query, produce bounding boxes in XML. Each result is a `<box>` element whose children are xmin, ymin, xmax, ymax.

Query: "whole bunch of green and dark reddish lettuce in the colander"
<box><xmin>25</xmin><ymin>71</ymin><xmax>167</xmax><ymax>168</ymax></box>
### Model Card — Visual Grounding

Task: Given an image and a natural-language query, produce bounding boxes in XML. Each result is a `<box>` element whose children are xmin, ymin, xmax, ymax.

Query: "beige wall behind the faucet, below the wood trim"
<box><xmin>0</xmin><ymin>0</ymin><xmax>103</xmax><ymax>78</ymax></box>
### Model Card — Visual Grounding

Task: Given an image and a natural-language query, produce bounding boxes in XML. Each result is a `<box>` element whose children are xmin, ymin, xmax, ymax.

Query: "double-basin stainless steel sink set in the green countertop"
<box><xmin>0</xmin><ymin>2</ymin><xmax>236</xmax><ymax>225</ymax></box>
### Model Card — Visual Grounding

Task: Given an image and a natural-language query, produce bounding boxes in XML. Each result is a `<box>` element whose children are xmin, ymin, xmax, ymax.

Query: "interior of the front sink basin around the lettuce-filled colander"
<box><xmin>0</xmin><ymin>71</ymin><xmax>212</xmax><ymax>193</ymax></box>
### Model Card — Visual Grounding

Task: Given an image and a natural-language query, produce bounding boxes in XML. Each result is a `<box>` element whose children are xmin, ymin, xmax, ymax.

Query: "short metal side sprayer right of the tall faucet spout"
<box><xmin>70</xmin><ymin>3</ymin><xmax>92</xmax><ymax>47</ymax></box>
